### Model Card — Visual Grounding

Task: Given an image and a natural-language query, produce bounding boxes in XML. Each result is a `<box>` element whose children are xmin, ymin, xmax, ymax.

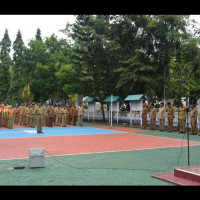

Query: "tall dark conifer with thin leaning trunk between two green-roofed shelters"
<box><xmin>66</xmin><ymin>15</ymin><xmax>117</xmax><ymax>121</ymax></box>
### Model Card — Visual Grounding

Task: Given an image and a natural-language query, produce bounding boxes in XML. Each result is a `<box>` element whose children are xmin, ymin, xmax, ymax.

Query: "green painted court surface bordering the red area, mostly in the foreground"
<box><xmin>0</xmin><ymin>124</ymin><xmax>200</xmax><ymax>186</ymax></box>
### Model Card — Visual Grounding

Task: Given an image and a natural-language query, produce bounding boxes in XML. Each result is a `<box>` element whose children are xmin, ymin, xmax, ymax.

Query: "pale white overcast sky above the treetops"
<box><xmin>0</xmin><ymin>15</ymin><xmax>200</xmax><ymax>45</ymax></box>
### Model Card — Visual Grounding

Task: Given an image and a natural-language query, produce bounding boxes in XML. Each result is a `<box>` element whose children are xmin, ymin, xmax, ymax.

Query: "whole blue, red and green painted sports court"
<box><xmin>0</xmin><ymin>123</ymin><xmax>200</xmax><ymax>185</ymax></box>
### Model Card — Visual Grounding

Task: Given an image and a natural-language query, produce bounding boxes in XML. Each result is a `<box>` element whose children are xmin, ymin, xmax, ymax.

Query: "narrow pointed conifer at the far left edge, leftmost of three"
<box><xmin>0</xmin><ymin>29</ymin><xmax>12</xmax><ymax>103</ymax></box>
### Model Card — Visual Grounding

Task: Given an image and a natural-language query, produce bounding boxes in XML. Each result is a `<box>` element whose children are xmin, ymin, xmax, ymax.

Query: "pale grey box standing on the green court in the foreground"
<box><xmin>29</xmin><ymin>148</ymin><xmax>45</xmax><ymax>168</ymax></box>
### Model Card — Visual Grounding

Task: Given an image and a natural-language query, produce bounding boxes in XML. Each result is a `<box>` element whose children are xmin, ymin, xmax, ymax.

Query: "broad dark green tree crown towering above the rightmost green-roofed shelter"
<box><xmin>110</xmin><ymin>15</ymin><xmax>187</xmax><ymax>100</ymax></box>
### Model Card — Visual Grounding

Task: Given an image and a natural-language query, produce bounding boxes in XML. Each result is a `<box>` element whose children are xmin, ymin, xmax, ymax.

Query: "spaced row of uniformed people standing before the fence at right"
<box><xmin>142</xmin><ymin>102</ymin><xmax>200</xmax><ymax>135</ymax></box>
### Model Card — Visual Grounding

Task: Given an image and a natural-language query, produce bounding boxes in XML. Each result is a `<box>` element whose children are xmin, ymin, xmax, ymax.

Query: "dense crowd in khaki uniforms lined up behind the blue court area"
<box><xmin>0</xmin><ymin>103</ymin><xmax>84</xmax><ymax>128</ymax></box>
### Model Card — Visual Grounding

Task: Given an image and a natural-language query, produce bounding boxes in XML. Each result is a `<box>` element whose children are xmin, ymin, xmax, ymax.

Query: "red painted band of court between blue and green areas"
<box><xmin>0</xmin><ymin>126</ymin><xmax>200</xmax><ymax>160</ymax></box>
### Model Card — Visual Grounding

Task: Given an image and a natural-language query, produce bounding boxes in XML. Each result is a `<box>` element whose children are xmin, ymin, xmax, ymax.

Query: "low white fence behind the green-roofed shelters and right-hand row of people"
<box><xmin>84</xmin><ymin>109</ymin><xmax>200</xmax><ymax>130</ymax></box>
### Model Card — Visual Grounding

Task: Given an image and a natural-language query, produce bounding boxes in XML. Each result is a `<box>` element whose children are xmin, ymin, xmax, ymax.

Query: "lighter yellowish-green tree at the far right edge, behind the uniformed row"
<box><xmin>167</xmin><ymin>39</ymin><xmax>200</xmax><ymax>103</ymax></box>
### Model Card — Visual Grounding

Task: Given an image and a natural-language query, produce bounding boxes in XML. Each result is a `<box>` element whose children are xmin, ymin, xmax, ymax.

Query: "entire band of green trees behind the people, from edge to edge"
<box><xmin>0</xmin><ymin>15</ymin><xmax>200</xmax><ymax>105</ymax></box>
